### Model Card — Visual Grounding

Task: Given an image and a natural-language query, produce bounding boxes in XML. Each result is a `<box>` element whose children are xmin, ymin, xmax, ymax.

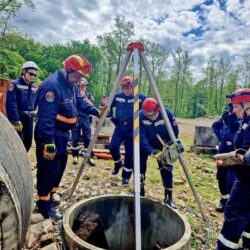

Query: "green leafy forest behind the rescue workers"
<box><xmin>0</xmin><ymin>0</ymin><xmax>250</xmax><ymax>118</ymax></box>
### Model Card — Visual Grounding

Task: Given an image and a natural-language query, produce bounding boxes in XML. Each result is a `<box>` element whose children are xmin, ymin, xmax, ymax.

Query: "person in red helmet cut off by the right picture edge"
<box><xmin>217</xmin><ymin>88</ymin><xmax>250</xmax><ymax>250</ymax></box>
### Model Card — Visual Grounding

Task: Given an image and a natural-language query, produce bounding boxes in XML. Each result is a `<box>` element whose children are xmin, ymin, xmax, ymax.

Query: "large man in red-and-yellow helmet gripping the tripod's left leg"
<box><xmin>35</xmin><ymin>55</ymin><xmax>104</xmax><ymax>220</ymax></box>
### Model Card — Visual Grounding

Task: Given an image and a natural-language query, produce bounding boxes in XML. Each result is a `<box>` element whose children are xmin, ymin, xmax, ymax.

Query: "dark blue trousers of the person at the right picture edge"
<box><xmin>217</xmin><ymin>179</ymin><xmax>250</xmax><ymax>250</ymax></box>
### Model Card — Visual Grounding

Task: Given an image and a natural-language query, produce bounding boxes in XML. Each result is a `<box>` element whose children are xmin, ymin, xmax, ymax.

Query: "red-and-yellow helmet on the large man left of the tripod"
<box><xmin>63</xmin><ymin>54</ymin><xmax>92</xmax><ymax>76</ymax></box>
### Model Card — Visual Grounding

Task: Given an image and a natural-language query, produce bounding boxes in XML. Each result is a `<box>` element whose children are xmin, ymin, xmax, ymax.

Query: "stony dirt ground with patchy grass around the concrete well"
<box><xmin>29</xmin><ymin>119</ymin><xmax>223</xmax><ymax>249</ymax></box>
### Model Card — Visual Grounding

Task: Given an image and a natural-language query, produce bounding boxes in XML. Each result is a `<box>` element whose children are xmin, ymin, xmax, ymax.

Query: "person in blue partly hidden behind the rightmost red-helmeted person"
<box><xmin>212</xmin><ymin>104</ymin><xmax>240</xmax><ymax>212</ymax></box>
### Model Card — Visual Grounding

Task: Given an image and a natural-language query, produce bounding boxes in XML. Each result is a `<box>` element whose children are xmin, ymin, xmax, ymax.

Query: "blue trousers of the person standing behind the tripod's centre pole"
<box><xmin>109</xmin><ymin>125</ymin><xmax>134</xmax><ymax>179</ymax></box>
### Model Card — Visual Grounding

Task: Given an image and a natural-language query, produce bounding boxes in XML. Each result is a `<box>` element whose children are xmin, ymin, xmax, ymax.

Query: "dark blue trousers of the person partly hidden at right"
<box><xmin>217</xmin><ymin>166</ymin><xmax>235</xmax><ymax>199</ymax></box>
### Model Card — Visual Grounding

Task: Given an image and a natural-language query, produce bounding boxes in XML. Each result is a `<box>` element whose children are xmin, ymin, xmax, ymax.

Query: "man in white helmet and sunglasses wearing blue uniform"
<box><xmin>6</xmin><ymin>61</ymin><xmax>38</xmax><ymax>152</ymax></box>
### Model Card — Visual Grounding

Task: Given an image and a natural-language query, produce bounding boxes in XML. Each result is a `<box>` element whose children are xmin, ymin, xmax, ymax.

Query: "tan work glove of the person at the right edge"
<box><xmin>214</xmin><ymin>149</ymin><xmax>244</xmax><ymax>167</ymax></box>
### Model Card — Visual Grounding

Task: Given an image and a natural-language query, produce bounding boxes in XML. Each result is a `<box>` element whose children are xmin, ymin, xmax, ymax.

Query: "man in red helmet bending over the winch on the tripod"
<box><xmin>140</xmin><ymin>98</ymin><xmax>179</xmax><ymax>208</ymax></box>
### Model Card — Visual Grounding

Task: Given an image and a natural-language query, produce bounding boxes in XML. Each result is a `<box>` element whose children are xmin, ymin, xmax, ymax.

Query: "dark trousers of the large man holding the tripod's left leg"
<box><xmin>35</xmin><ymin>130</ymin><xmax>68</xmax><ymax>217</ymax></box>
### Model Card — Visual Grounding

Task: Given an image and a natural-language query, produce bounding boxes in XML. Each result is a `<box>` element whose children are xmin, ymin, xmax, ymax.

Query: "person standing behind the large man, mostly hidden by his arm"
<box><xmin>72</xmin><ymin>78</ymin><xmax>95</xmax><ymax>167</ymax></box>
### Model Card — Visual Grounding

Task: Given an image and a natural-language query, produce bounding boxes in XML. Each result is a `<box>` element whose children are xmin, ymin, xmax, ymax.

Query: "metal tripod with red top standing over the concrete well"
<box><xmin>68</xmin><ymin>43</ymin><xmax>207</xmax><ymax>250</ymax></box>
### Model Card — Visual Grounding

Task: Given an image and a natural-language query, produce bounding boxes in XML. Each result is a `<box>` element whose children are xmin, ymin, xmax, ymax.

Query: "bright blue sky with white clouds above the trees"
<box><xmin>15</xmin><ymin>0</ymin><xmax>250</xmax><ymax>79</ymax></box>
